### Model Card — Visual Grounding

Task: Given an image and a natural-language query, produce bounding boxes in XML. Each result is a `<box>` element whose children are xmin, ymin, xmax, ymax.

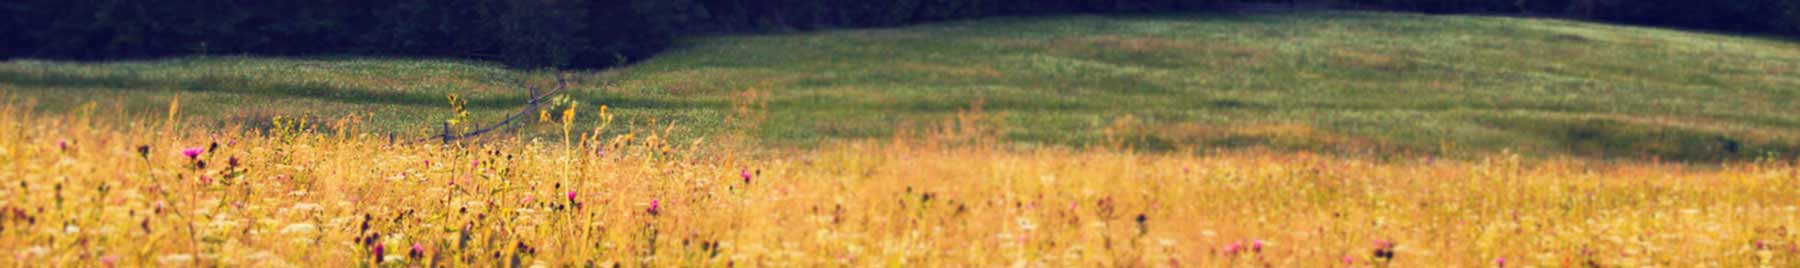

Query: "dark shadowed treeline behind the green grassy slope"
<box><xmin>0</xmin><ymin>0</ymin><xmax>1800</xmax><ymax>68</ymax></box>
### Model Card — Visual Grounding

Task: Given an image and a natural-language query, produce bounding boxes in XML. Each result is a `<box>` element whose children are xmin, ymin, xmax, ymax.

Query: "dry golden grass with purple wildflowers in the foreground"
<box><xmin>0</xmin><ymin>98</ymin><xmax>1800</xmax><ymax>266</ymax></box>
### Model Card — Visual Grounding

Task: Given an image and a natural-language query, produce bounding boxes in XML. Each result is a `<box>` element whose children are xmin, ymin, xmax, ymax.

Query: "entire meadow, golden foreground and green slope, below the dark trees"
<box><xmin>0</xmin><ymin>11</ymin><xmax>1800</xmax><ymax>266</ymax></box>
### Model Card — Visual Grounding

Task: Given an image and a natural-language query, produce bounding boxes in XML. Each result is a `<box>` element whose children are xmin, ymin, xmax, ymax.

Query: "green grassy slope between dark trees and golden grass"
<box><xmin>0</xmin><ymin>11</ymin><xmax>1800</xmax><ymax>160</ymax></box>
